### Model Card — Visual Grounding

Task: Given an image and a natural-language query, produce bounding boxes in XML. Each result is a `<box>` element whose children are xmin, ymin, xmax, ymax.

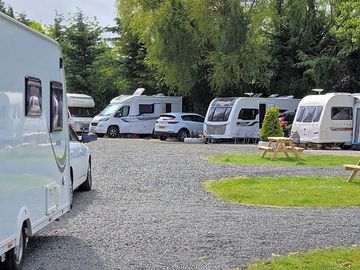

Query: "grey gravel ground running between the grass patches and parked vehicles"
<box><xmin>24</xmin><ymin>139</ymin><xmax>360</xmax><ymax>270</ymax></box>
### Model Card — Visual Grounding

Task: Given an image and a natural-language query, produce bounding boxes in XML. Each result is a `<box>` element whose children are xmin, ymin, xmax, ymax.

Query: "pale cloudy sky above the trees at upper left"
<box><xmin>3</xmin><ymin>0</ymin><xmax>116</xmax><ymax>26</ymax></box>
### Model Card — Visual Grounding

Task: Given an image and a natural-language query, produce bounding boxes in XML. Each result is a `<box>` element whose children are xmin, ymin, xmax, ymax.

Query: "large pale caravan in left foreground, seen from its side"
<box><xmin>0</xmin><ymin>12</ymin><xmax>72</xmax><ymax>270</ymax></box>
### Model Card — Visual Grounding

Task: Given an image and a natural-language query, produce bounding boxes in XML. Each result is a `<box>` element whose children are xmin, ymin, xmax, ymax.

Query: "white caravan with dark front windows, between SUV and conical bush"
<box><xmin>204</xmin><ymin>96</ymin><xmax>300</xmax><ymax>139</ymax></box>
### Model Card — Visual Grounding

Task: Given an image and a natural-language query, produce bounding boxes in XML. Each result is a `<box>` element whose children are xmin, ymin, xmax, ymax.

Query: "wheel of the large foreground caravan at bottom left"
<box><xmin>0</xmin><ymin>226</ymin><xmax>27</xmax><ymax>270</ymax></box>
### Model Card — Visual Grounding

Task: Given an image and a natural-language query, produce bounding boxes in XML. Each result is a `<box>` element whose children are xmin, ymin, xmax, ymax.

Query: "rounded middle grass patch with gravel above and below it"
<box><xmin>204</xmin><ymin>176</ymin><xmax>360</xmax><ymax>207</ymax></box>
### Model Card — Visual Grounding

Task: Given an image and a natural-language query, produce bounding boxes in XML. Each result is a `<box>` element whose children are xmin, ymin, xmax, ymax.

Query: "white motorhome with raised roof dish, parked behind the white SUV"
<box><xmin>90</xmin><ymin>88</ymin><xmax>182</xmax><ymax>138</ymax></box>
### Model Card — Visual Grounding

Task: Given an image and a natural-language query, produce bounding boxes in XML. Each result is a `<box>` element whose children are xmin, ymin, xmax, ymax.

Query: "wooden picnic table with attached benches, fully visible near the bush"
<box><xmin>259</xmin><ymin>137</ymin><xmax>304</xmax><ymax>160</ymax></box>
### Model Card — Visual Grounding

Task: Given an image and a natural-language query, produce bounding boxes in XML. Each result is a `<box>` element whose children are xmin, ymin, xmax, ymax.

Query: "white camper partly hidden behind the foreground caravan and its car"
<box><xmin>66</xmin><ymin>93</ymin><xmax>95</xmax><ymax>134</ymax></box>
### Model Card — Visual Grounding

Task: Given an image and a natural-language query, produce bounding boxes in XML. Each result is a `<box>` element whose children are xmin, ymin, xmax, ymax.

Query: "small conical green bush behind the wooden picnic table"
<box><xmin>260</xmin><ymin>107</ymin><xmax>284</xmax><ymax>141</ymax></box>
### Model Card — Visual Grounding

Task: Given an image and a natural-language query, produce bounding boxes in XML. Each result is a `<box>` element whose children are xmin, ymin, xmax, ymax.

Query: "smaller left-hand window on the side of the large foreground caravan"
<box><xmin>25</xmin><ymin>77</ymin><xmax>42</xmax><ymax>116</ymax></box>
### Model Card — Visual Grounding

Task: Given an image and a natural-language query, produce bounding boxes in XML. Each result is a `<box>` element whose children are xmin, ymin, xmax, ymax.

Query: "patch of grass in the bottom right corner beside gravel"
<box><xmin>245</xmin><ymin>246</ymin><xmax>360</xmax><ymax>270</ymax></box>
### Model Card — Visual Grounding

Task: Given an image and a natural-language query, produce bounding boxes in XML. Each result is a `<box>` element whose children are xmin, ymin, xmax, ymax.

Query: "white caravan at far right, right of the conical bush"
<box><xmin>291</xmin><ymin>93</ymin><xmax>360</xmax><ymax>148</ymax></box>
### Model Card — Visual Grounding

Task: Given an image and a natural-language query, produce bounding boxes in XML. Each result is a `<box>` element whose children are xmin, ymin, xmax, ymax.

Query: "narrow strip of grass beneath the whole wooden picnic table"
<box><xmin>207</xmin><ymin>154</ymin><xmax>359</xmax><ymax>167</ymax></box>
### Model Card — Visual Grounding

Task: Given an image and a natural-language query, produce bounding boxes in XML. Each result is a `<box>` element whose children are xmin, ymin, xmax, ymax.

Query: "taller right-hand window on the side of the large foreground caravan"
<box><xmin>50</xmin><ymin>82</ymin><xmax>64</xmax><ymax>131</ymax></box>
